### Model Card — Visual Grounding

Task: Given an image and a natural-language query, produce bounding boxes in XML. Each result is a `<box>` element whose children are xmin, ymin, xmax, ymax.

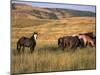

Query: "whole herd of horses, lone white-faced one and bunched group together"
<box><xmin>17</xmin><ymin>32</ymin><xmax>96</xmax><ymax>53</ymax></box>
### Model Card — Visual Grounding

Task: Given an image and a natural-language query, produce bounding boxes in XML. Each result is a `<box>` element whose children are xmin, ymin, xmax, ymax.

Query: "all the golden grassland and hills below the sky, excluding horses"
<box><xmin>11</xmin><ymin>4</ymin><xmax>96</xmax><ymax>74</ymax></box>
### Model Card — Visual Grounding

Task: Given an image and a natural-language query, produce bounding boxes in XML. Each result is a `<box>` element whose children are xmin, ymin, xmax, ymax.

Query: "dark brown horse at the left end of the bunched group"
<box><xmin>58</xmin><ymin>36</ymin><xmax>81</xmax><ymax>50</ymax></box>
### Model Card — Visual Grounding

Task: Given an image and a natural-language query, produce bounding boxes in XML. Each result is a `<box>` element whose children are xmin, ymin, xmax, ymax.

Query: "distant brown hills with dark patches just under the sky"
<box><xmin>12</xmin><ymin>3</ymin><xmax>96</xmax><ymax>19</ymax></box>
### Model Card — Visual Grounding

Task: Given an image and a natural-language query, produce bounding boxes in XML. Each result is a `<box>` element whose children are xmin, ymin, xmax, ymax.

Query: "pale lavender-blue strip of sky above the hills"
<box><xmin>12</xmin><ymin>1</ymin><xmax>96</xmax><ymax>13</ymax></box>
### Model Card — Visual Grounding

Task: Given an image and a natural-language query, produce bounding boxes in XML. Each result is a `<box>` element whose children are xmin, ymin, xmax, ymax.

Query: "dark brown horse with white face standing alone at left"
<box><xmin>17</xmin><ymin>32</ymin><xmax>37</xmax><ymax>53</ymax></box>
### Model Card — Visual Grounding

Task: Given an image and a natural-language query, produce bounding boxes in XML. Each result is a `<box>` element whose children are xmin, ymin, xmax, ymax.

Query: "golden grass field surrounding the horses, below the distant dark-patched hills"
<box><xmin>11</xmin><ymin>17</ymin><xmax>96</xmax><ymax>73</ymax></box>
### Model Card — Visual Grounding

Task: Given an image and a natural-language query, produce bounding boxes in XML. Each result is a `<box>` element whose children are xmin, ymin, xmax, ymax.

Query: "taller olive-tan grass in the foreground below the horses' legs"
<box><xmin>12</xmin><ymin>44</ymin><xmax>96</xmax><ymax>73</ymax></box>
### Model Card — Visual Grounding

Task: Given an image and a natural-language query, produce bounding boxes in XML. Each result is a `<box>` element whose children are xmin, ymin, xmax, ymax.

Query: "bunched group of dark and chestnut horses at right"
<box><xmin>58</xmin><ymin>32</ymin><xmax>96</xmax><ymax>50</ymax></box>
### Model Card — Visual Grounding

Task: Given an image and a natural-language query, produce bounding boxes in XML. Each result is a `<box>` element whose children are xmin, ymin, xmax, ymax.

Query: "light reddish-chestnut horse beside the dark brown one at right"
<box><xmin>77</xmin><ymin>35</ymin><xmax>95</xmax><ymax>46</ymax></box>
